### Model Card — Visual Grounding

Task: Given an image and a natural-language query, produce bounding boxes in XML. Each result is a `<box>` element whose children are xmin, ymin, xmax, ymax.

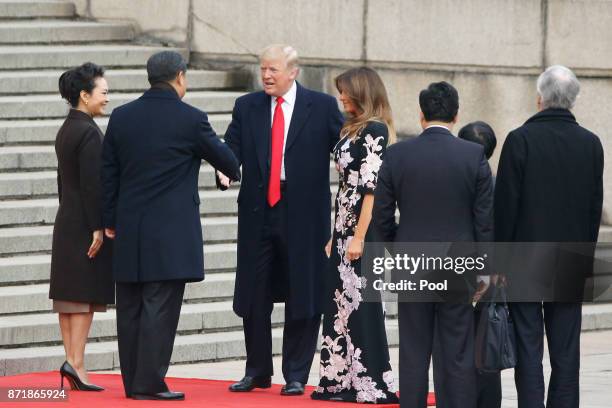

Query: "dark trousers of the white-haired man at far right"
<box><xmin>510</xmin><ymin>303</ymin><xmax>582</xmax><ymax>408</ymax></box>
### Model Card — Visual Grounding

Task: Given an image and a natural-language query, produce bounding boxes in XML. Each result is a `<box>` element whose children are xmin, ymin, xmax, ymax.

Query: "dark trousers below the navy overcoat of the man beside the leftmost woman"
<box><xmin>117</xmin><ymin>281</ymin><xmax>185</xmax><ymax>397</ymax></box>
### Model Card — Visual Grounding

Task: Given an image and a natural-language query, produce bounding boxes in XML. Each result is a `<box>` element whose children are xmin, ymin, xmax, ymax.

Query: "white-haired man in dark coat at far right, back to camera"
<box><xmin>495</xmin><ymin>66</ymin><xmax>603</xmax><ymax>408</ymax></box>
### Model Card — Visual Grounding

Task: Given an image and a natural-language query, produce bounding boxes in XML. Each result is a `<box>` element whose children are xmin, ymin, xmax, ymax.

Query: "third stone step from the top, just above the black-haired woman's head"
<box><xmin>0</xmin><ymin>44</ymin><xmax>189</xmax><ymax>70</ymax></box>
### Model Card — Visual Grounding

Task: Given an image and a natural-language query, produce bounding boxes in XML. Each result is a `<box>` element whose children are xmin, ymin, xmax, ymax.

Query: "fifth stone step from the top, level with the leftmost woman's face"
<box><xmin>0</xmin><ymin>91</ymin><xmax>243</xmax><ymax>119</ymax></box>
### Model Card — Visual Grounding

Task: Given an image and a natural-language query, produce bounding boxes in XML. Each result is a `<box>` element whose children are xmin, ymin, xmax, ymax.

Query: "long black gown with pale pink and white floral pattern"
<box><xmin>312</xmin><ymin>121</ymin><xmax>397</xmax><ymax>403</ymax></box>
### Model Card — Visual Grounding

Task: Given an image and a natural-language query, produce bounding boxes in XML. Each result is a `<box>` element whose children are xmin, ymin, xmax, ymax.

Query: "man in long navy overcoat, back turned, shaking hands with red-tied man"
<box><xmin>102</xmin><ymin>51</ymin><xmax>240</xmax><ymax>400</ymax></box>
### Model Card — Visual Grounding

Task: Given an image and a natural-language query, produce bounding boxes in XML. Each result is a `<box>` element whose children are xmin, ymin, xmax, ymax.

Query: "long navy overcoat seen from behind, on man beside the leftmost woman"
<box><xmin>102</xmin><ymin>88</ymin><xmax>240</xmax><ymax>282</ymax></box>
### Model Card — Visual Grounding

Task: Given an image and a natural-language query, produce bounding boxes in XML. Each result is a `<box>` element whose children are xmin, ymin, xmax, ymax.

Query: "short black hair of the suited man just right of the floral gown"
<box><xmin>419</xmin><ymin>81</ymin><xmax>459</xmax><ymax>123</ymax></box>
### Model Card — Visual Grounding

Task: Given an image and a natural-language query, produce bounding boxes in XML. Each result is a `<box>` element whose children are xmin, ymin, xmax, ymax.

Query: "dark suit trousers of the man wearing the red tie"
<box><xmin>243</xmin><ymin>193</ymin><xmax>321</xmax><ymax>384</ymax></box>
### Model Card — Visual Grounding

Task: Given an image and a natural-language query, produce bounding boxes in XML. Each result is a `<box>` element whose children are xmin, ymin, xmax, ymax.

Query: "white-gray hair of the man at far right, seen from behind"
<box><xmin>537</xmin><ymin>65</ymin><xmax>580</xmax><ymax>109</ymax></box>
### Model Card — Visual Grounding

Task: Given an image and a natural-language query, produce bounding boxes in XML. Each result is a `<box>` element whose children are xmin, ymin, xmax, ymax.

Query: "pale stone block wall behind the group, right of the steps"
<box><xmin>76</xmin><ymin>0</ymin><xmax>612</xmax><ymax>224</ymax></box>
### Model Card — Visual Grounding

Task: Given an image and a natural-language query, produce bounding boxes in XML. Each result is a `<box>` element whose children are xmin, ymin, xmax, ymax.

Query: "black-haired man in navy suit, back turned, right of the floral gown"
<box><xmin>373</xmin><ymin>82</ymin><xmax>493</xmax><ymax>408</ymax></box>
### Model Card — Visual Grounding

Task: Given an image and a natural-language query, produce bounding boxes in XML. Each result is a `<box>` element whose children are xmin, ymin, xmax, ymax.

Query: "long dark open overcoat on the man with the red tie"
<box><xmin>225</xmin><ymin>84</ymin><xmax>343</xmax><ymax>319</ymax></box>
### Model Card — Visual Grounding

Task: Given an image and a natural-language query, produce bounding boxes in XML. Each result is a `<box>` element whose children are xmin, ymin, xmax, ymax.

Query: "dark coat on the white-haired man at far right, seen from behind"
<box><xmin>495</xmin><ymin>109</ymin><xmax>604</xmax><ymax>301</ymax></box>
